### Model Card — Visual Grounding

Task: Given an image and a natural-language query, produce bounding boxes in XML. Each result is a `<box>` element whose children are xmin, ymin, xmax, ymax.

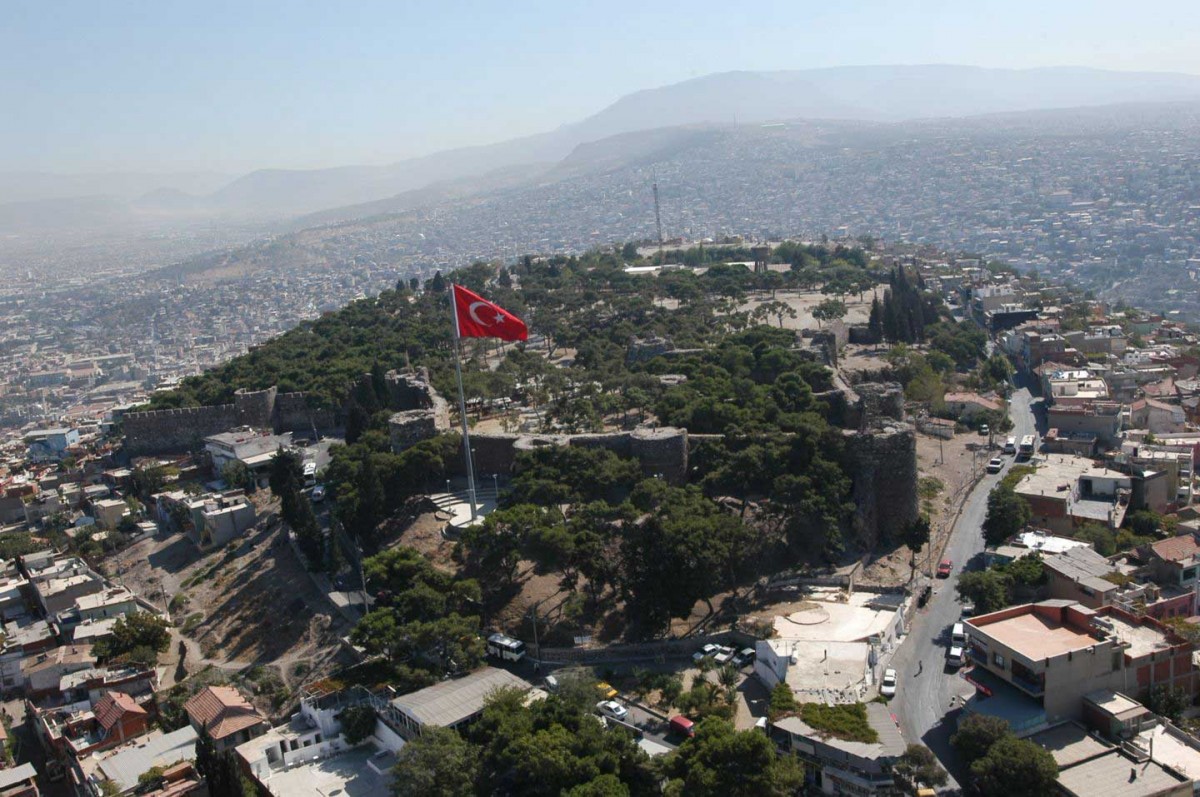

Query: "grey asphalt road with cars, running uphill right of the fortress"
<box><xmin>890</xmin><ymin>386</ymin><xmax>1040</xmax><ymax>775</ymax></box>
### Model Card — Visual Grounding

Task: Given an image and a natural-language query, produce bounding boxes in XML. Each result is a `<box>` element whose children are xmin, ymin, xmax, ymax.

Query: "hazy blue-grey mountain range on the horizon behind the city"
<box><xmin>7</xmin><ymin>65</ymin><xmax>1200</xmax><ymax>232</ymax></box>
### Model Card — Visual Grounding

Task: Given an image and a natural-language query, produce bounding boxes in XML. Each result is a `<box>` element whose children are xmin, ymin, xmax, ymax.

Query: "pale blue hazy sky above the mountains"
<box><xmin>0</xmin><ymin>0</ymin><xmax>1200</xmax><ymax>173</ymax></box>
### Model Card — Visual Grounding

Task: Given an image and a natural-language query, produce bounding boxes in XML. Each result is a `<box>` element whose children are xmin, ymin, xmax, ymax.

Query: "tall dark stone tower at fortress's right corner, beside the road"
<box><xmin>844</xmin><ymin>421</ymin><xmax>919</xmax><ymax>550</ymax></box>
